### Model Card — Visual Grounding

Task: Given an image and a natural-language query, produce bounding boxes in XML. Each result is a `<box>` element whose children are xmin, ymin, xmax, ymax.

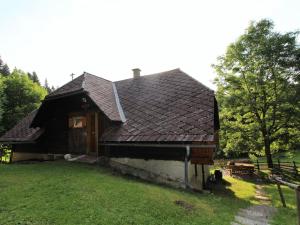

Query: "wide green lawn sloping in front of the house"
<box><xmin>0</xmin><ymin>161</ymin><xmax>254</xmax><ymax>225</ymax></box>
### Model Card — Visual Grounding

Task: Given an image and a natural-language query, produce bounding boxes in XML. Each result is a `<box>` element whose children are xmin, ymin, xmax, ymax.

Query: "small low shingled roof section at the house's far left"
<box><xmin>0</xmin><ymin>110</ymin><xmax>44</xmax><ymax>143</ymax></box>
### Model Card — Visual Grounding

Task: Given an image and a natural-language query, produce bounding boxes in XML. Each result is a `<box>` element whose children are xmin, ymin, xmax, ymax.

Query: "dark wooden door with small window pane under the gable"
<box><xmin>69</xmin><ymin>115</ymin><xmax>87</xmax><ymax>154</ymax></box>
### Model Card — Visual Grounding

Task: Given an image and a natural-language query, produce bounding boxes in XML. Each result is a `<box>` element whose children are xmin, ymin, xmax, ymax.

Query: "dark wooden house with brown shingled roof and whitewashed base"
<box><xmin>0</xmin><ymin>69</ymin><xmax>219</xmax><ymax>189</ymax></box>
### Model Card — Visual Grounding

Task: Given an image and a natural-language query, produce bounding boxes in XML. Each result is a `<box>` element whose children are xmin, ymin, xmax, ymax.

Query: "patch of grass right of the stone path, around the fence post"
<box><xmin>264</xmin><ymin>184</ymin><xmax>297</xmax><ymax>225</ymax></box>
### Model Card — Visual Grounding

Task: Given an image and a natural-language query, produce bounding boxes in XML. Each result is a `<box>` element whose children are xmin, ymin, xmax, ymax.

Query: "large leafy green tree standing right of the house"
<box><xmin>213</xmin><ymin>20</ymin><xmax>300</xmax><ymax>168</ymax></box>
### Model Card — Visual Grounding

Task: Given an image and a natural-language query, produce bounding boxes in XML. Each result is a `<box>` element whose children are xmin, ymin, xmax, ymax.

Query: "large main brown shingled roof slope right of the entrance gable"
<box><xmin>102</xmin><ymin>69</ymin><xmax>216</xmax><ymax>142</ymax></box>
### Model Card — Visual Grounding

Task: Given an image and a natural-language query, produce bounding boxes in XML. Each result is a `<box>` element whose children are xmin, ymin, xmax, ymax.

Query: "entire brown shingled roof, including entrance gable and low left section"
<box><xmin>0</xmin><ymin>69</ymin><xmax>219</xmax><ymax>142</ymax></box>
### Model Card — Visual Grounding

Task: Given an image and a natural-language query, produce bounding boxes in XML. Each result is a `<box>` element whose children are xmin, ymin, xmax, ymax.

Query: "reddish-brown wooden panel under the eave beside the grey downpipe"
<box><xmin>191</xmin><ymin>148</ymin><xmax>214</xmax><ymax>165</ymax></box>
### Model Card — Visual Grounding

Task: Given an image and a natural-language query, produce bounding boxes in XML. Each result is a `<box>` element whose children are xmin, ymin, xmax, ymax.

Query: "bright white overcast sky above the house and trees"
<box><xmin>0</xmin><ymin>0</ymin><xmax>300</xmax><ymax>89</ymax></box>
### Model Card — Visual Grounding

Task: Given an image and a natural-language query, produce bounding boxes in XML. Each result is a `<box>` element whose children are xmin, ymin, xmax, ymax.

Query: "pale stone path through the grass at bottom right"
<box><xmin>231</xmin><ymin>184</ymin><xmax>276</xmax><ymax>225</ymax></box>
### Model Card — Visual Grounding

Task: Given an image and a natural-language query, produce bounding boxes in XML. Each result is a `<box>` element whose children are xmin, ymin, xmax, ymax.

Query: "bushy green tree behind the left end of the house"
<box><xmin>2</xmin><ymin>69</ymin><xmax>47</xmax><ymax>130</ymax></box>
